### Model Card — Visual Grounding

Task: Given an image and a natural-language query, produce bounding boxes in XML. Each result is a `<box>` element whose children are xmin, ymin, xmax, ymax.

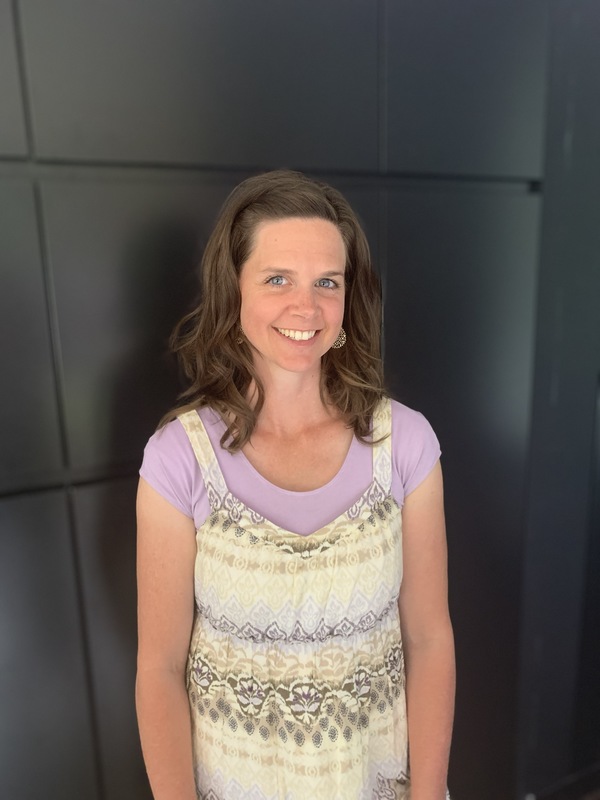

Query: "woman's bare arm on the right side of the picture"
<box><xmin>400</xmin><ymin>462</ymin><xmax>455</xmax><ymax>800</ymax></box>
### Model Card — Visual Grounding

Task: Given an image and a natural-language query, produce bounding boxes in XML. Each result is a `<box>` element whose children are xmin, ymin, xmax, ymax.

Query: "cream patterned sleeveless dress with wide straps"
<box><xmin>179</xmin><ymin>400</ymin><xmax>410</xmax><ymax>800</ymax></box>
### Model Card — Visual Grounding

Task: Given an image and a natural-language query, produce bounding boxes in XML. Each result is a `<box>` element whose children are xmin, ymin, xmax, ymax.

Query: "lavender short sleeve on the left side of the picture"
<box><xmin>140</xmin><ymin>420</ymin><xmax>196</xmax><ymax>518</ymax></box>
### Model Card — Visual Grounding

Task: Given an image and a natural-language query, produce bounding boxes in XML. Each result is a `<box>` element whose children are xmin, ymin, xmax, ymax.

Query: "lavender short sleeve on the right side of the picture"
<box><xmin>392</xmin><ymin>401</ymin><xmax>441</xmax><ymax>505</ymax></box>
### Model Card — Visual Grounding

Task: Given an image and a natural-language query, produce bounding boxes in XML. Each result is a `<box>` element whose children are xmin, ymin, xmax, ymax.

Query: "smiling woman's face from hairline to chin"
<box><xmin>240</xmin><ymin>217</ymin><xmax>346</xmax><ymax>382</ymax></box>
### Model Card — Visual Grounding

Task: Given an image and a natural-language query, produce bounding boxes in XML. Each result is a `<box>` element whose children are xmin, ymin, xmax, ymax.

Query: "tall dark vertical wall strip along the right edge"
<box><xmin>520</xmin><ymin>0</ymin><xmax>600</xmax><ymax>794</ymax></box>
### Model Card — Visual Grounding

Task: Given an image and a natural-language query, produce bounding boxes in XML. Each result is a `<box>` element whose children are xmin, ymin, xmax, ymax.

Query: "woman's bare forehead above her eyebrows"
<box><xmin>249</xmin><ymin>217</ymin><xmax>346</xmax><ymax>264</ymax></box>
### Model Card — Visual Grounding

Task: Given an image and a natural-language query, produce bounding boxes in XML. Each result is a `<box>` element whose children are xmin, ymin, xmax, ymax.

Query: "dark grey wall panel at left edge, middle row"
<box><xmin>0</xmin><ymin>179</ymin><xmax>61</xmax><ymax>491</ymax></box>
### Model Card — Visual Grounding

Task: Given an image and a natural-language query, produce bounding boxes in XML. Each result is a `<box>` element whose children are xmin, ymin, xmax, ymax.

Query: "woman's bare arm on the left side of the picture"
<box><xmin>136</xmin><ymin>479</ymin><xmax>196</xmax><ymax>800</ymax></box>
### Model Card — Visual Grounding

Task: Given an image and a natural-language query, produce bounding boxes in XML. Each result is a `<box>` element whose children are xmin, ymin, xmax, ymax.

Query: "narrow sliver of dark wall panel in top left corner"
<box><xmin>0</xmin><ymin>0</ymin><xmax>27</xmax><ymax>156</ymax></box>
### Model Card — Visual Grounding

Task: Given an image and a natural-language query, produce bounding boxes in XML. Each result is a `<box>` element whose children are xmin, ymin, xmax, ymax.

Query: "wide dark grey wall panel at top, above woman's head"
<box><xmin>21</xmin><ymin>0</ymin><xmax>378</xmax><ymax>170</ymax></box>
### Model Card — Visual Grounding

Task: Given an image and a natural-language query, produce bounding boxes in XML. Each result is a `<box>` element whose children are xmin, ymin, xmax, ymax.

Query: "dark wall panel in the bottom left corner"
<box><xmin>0</xmin><ymin>492</ymin><xmax>98</xmax><ymax>800</ymax></box>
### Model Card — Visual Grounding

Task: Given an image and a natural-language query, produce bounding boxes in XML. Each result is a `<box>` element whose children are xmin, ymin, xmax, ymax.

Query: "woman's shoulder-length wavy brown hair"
<box><xmin>159</xmin><ymin>170</ymin><xmax>385</xmax><ymax>452</ymax></box>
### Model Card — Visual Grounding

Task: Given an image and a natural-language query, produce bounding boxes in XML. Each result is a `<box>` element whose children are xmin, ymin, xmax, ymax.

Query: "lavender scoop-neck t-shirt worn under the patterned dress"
<box><xmin>140</xmin><ymin>400</ymin><xmax>440</xmax><ymax>535</ymax></box>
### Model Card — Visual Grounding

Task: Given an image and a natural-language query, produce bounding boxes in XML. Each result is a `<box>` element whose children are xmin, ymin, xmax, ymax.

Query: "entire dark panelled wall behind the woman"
<box><xmin>0</xmin><ymin>0</ymin><xmax>580</xmax><ymax>800</ymax></box>
